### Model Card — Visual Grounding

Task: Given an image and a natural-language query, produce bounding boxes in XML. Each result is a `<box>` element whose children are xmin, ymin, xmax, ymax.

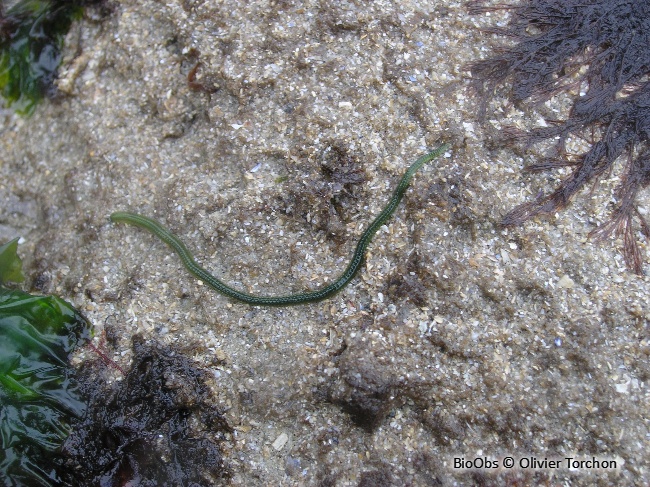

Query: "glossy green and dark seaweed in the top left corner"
<box><xmin>0</xmin><ymin>0</ymin><xmax>88</xmax><ymax>115</ymax></box>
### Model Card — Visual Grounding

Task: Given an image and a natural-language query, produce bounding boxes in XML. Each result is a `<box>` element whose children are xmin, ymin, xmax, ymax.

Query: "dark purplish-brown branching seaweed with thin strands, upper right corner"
<box><xmin>470</xmin><ymin>0</ymin><xmax>650</xmax><ymax>274</ymax></box>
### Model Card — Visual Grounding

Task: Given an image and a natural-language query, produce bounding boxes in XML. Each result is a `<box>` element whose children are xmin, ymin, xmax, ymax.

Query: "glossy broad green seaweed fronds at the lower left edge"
<box><xmin>0</xmin><ymin>240</ymin><xmax>90</xmax><ymax>487</ymax></box>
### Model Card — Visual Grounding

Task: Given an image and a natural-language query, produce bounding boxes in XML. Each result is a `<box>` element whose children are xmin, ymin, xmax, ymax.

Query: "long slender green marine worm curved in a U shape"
<box><xmin>111</xmin><ymin>144</ymin><xmax>449</xmax><ymax>306</ymax></box>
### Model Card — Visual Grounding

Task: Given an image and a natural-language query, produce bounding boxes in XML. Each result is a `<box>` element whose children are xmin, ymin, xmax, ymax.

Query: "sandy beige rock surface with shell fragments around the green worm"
<box><xmin>0</xmin><ymin>0</ymin><xmax>650</xmax><ymax>486</ymax></box>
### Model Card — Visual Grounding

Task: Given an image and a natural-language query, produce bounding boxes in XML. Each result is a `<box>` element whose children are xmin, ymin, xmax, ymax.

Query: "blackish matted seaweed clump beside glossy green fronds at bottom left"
<box><xmin>64</xmin><ymin>336</ymin><xmax>231</xmax><ymax>487</ymax></box>
